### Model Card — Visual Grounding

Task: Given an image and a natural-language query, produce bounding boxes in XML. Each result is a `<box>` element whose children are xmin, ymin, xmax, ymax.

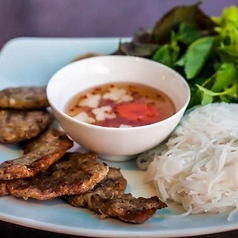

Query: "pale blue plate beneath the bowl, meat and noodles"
<box><xmin>0</xmin><ymin>38</ymin><xmax>238</xmax><ymax>238</ymax></box>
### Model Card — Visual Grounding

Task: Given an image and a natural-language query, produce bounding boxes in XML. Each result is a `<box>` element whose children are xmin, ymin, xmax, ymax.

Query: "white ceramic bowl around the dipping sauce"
<box><xmin>47</xmin><ymin>56</ymin><xmax>190</xmax><ymax>161</ymax></box>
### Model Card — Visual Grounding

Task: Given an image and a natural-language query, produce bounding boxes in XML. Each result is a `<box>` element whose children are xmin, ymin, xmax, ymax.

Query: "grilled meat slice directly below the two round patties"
<box><xmin>0</xmin><ymin>129</ymin><xmax>73</xmax><ymax>180</ymax></box>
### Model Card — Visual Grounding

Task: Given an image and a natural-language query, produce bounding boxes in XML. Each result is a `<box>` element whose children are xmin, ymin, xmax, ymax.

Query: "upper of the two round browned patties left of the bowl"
<box><xmin>0</xmin><ymin>86</ymin><xmax>49</xmax><ymax>109</ymax></box>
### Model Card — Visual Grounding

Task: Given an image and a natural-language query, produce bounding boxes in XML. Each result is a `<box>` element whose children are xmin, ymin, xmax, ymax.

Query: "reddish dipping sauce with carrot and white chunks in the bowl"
<box><xmin>66</xmin><ymin>83</ymin><xmax>175</xmax><ymax>127</ymax></box>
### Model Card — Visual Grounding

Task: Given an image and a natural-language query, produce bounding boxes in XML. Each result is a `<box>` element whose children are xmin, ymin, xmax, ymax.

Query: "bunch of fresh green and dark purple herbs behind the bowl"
<box><xmin>118</xmin><ymin>2</ymin><xmax>238</xmax><ymax>107</ymax></box>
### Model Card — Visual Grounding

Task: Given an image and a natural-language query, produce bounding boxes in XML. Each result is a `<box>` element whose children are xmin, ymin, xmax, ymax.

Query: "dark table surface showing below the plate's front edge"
<box><xmin>0</xmin><ymin>221</ymin><xmax>238</xmax><ymax>238</ymax></box>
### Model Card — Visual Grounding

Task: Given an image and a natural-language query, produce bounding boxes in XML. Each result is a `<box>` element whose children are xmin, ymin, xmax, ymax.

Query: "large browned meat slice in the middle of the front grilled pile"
<box><xmin>7</xmin><ymin>152</ymin><xmax>108</xmax><ymax>200</ymax></box>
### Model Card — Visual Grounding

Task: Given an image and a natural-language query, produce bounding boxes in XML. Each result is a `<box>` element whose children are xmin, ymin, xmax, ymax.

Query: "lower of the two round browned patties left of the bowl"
<box><xmin>0</xmin><ymin>110</ymin><xmax>53</xmax><ymax>144</ymax></box>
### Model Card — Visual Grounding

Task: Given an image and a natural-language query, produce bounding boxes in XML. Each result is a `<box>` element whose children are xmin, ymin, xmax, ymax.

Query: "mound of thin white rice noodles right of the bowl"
<box><xmin>138</xmin><ymin>103</ymin><xmax>238</xmax><ymax>216</ymax></box>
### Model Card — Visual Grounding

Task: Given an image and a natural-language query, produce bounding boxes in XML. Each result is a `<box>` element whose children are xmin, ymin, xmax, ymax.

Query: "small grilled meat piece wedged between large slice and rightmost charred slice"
<box><xmin>65</xmin><ymin>167</ymin><xmax>127</xmax><ymax>208</ymax></box>
